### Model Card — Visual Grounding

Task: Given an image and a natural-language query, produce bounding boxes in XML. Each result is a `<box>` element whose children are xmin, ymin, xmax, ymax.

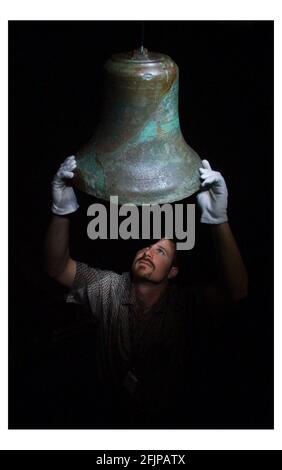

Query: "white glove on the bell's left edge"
<box><xmin>51</xmin><ymin>155</ymin><xmax>79</xmax><ymax>215</ymax></box>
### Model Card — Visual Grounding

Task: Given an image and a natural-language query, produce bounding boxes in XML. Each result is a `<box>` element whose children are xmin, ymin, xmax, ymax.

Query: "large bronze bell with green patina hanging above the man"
<box><xmin>74</xmin><ymin>49</ymin><xmax>201</xmax><ymax>205</ymax></box>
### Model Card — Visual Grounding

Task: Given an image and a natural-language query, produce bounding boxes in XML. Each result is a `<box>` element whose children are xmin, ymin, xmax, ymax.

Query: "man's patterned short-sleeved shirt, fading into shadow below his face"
<box><xmin>66</xmin><ymin>262</ymin><xmax>204</xmax><ymax>409</ymax></box>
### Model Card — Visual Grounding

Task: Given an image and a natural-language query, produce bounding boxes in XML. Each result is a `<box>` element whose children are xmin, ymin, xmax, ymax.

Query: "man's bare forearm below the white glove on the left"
<box><xmin>45</xmin><ymin>215</ymin><xmax>70</xmax><ymax>277</ymax></box>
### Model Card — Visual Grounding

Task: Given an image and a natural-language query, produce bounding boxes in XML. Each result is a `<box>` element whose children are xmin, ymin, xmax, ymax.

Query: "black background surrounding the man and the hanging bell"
<box><xmin>9</xmin><ymin>21</ymin><xmax>273</xmax><ymax>428</ymax></box>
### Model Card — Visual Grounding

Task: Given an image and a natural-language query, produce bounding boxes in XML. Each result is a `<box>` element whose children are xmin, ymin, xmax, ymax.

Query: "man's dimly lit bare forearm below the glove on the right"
<box><xmin>210</xmin><ymin>222</ymin><xmax>248</xmax><ymax>300</ymax></box>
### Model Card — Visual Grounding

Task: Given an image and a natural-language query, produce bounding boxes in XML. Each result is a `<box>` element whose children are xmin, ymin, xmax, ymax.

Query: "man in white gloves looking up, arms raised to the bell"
<box><xmin>46</xmin><ymin>156</ymin><xmax>248</xmax><ymax>426</ymax></box>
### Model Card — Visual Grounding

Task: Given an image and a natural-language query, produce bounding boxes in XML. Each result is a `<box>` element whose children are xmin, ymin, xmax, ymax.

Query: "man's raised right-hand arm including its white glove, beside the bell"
<box><xmin>197</xmin><ymin>160</ymin><xmax>248</xmax><ymax>303</ymax></box>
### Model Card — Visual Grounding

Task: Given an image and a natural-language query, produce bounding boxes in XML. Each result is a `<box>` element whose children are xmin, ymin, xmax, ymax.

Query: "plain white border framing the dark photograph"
<box><xmin>0</xmin><ymin>0</ymin><xmax>282</xmax><ymax>450</ymax></box>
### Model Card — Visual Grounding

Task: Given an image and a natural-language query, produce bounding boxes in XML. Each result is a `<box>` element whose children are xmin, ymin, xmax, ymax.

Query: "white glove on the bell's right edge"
<box><xmin>197</xmin><ymin>160</ymin><xmax>228</xmax><ymax>224</ymax></box>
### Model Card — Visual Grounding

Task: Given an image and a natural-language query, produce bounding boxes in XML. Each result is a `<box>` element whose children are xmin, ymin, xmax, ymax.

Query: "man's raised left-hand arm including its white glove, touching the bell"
<box><xmin>45</xmin><ymin>156</ymin><xmax>79</xmax><ymax>287</ymax></box>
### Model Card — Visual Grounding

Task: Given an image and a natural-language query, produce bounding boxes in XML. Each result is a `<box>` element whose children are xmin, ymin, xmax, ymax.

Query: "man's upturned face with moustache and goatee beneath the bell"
<box><xmin>131</xmin><ymin>238</ymin><xmax>178</xmax><ymax>284</ymax></box>
